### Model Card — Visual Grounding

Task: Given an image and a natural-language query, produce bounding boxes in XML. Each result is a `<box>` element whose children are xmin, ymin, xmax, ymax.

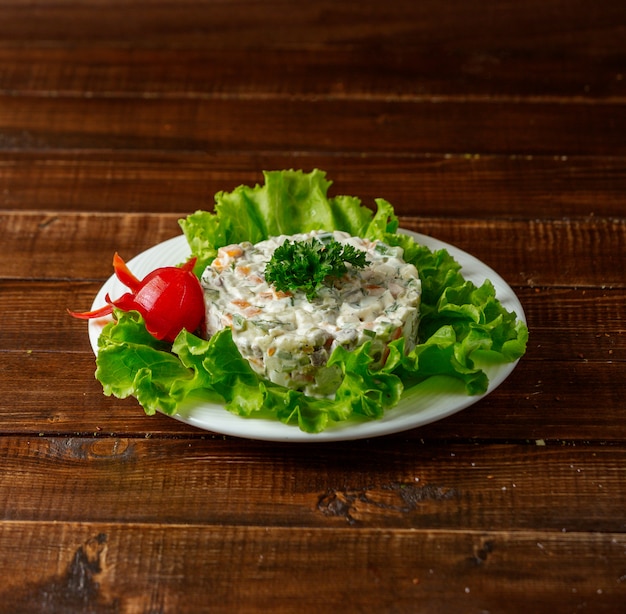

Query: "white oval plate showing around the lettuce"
<box><xmin>89</xmin><ymin>231</ymin><xmax>526</xmax><ymax>442</ymax></box>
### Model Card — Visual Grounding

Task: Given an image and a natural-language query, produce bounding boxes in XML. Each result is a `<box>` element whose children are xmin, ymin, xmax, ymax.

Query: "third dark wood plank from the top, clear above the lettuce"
<box><xmin>0</xmin><ymin>96</ymin><xmax>626</xmax><ymax>156</ymax></box>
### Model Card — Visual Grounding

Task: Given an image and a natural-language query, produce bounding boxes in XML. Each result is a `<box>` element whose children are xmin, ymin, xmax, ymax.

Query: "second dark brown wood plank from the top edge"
<box><xmin>0</xmin><ymin>44</ymin><xmax>626</xmax><ymax>104</ymax></box>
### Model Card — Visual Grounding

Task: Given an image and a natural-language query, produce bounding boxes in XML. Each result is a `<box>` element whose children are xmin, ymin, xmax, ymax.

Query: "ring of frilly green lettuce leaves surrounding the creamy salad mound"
<box><xmin>74</xmin><ymin>170</ymin><xmax>528</xmax><ymax>433</ymax></box>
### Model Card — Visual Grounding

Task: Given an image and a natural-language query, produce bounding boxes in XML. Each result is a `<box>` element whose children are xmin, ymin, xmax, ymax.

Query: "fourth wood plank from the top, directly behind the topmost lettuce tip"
<box><xmin>0</xmin><ymin>151</ymin><xmax>626</xmax><ymax>219</ymax></box>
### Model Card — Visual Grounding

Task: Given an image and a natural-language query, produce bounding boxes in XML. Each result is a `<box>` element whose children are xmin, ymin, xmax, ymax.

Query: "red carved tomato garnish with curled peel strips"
<box><xmin>68</xmin><ymin>253</ymin><xmax>205</xmax><ymax>342</ymax></box>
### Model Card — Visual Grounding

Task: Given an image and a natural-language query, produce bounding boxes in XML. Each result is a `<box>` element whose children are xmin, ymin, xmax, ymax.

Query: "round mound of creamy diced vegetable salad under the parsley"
<box><xmin>202</xmin><ymin>231</ymin><xmax>421</xmax><ymax>396</ymax></box>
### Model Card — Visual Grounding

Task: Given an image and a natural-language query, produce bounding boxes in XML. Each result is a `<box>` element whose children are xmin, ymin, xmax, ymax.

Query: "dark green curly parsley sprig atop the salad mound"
<box><xmin>265</xmin><ymin>238</ymin><xmax>367</xmax><ymax>301</ymax></box>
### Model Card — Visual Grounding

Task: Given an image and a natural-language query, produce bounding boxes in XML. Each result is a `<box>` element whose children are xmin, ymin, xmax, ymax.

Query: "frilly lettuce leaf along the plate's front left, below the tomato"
<box><xmin>96</xmin><ymin>310</ymin><xmax>390</xmax><ymax>433</ymax></box>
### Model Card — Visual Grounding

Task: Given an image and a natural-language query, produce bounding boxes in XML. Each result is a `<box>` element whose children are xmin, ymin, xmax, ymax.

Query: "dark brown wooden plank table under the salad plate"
<box><xmin>0</xmin><ymin>0</ymin><xmax>626</xmax><ymax>614</ymax></box>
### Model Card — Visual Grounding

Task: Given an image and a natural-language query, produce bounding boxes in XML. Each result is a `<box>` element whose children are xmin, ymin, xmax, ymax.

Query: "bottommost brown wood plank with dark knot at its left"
<box><xmin>0</xmin><ymin>521</ymin><xmax>626</xmax><ymax>614</ymax></box>
